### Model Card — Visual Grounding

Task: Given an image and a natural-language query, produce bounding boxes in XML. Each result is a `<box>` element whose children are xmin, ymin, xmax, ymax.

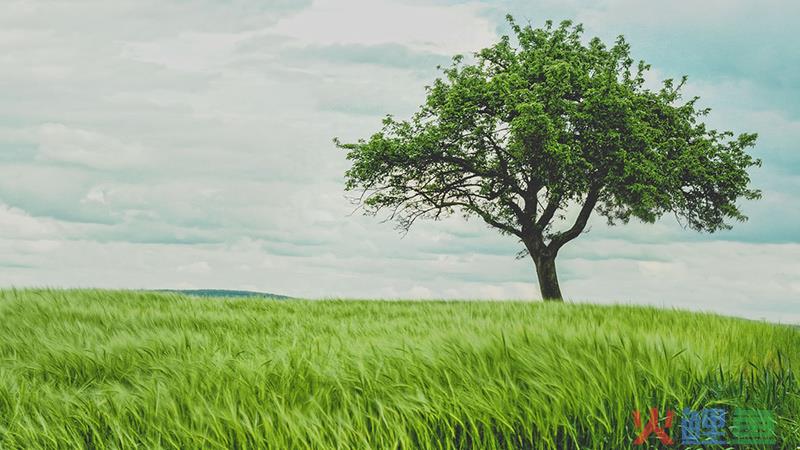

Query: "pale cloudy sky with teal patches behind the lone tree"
<box><xmin>0</xmin><ymin>0</ymin><xmax>800</xmax><ymax>323</ymax></box>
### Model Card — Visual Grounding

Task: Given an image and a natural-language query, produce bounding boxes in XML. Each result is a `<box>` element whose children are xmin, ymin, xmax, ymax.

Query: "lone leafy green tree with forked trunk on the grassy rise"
<box><xmin>334</xmin><ymin>16</ymin><xmax>761</xmax><ymax>300</ymax></box>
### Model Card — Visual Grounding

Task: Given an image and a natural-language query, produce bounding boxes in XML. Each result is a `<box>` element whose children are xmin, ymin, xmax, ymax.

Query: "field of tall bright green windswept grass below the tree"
<box><xmin>0</xmin><ymin>290</ymin><xmax>800</xmax><ymax>449</ymax></box>
